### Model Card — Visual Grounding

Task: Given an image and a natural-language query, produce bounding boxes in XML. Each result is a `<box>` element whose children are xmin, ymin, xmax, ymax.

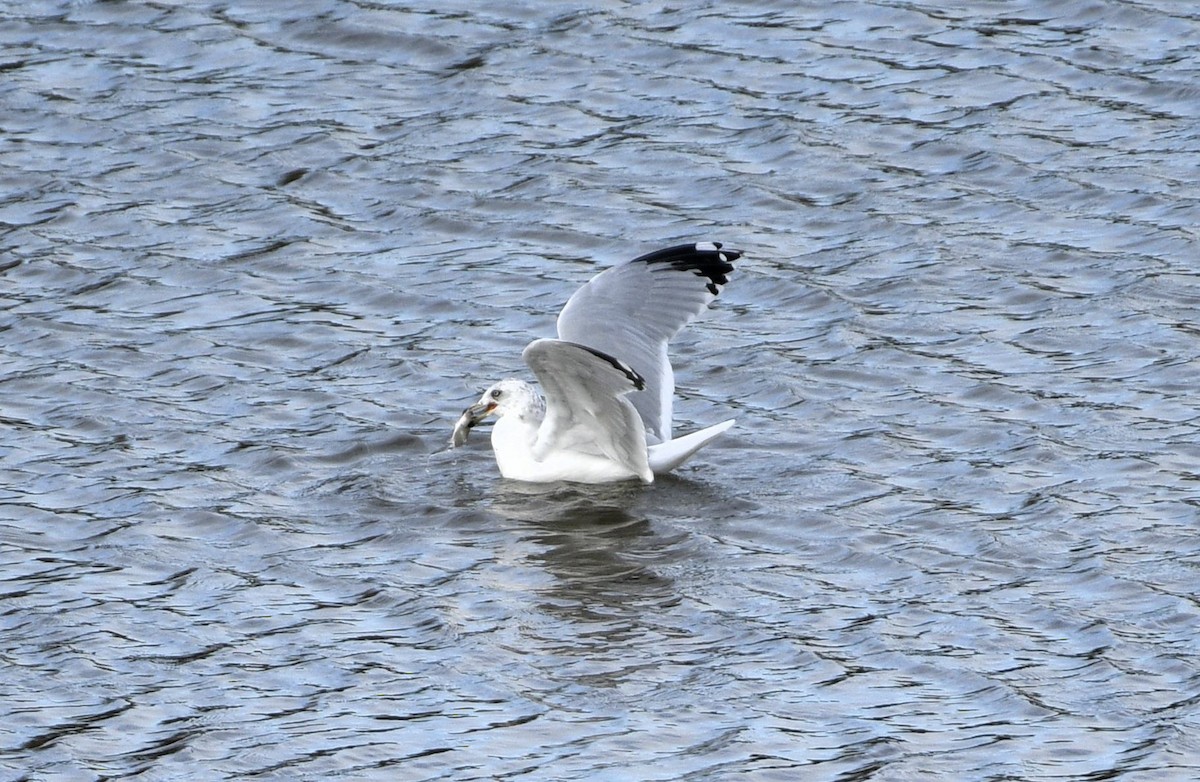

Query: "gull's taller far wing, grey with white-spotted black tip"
<box><xmin>556</xmin><ymin>242</ymin><xmax>742</xmax><ymax>443</ymax></box>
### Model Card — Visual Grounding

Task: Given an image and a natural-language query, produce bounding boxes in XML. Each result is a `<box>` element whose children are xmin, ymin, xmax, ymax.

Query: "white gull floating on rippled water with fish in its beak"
<box><xmin>451</xmin><ymin>242</ymin><xmax>742</xmax><ymax>483</ymax></box>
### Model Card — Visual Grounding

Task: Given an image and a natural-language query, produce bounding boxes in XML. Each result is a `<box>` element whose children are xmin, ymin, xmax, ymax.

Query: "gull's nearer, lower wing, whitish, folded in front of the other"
<box><xmin>521</xmin><ymin>339</ymin><xmax>653</xmax><ymax>481</ymax></box>
